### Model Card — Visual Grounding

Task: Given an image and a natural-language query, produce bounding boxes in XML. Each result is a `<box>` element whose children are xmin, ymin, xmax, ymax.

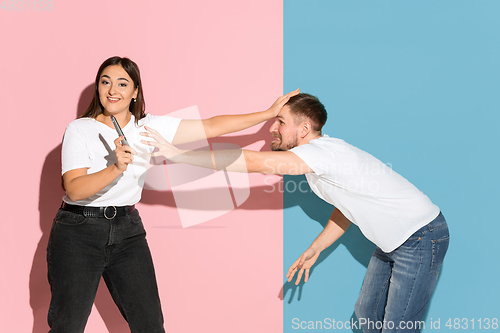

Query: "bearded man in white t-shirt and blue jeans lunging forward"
<box><xmin>143</xmin><ymin>94</ymin><xmax>449</xmax><ymax>332</ymax></box>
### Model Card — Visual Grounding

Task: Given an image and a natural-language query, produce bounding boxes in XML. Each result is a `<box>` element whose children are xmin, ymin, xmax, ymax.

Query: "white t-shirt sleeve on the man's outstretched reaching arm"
<box><xmin>290</xmin><ymin>143</ymin><xmax>334</xmax><ymax>176</ymax></box>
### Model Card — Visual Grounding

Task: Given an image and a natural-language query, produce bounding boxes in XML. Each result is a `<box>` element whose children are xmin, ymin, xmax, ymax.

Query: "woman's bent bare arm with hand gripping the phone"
<box><xmin>63</xmin><ymin>136</ymin><xmax>135</xmax><ymax>201</ymax></box>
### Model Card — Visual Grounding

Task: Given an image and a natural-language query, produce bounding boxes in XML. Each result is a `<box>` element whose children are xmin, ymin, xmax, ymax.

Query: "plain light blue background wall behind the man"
<box><xmin>283</xmin><ymin>0</ymin><xmax>500</xmax><ymax>332</ymax></box>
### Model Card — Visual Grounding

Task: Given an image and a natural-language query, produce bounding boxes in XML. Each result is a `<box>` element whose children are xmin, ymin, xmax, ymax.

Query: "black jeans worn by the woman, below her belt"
<box><xmin>47</xmin><ymin>209</ymin><xmax>165</xmax><ymax>333</ymax></box>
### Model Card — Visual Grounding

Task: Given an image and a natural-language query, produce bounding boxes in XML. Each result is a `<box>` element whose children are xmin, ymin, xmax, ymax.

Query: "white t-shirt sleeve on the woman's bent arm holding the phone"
<box><xmin>61</xmin><ymin>123</ymin><xmax>92</xmax><ymax>175</ymax></box>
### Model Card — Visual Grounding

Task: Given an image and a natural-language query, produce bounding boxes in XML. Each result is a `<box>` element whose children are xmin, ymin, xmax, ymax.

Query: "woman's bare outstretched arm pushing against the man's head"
<box><xmin>172</xmin><ymin>89</ymin><xmax>300</xmax><ymax>145</ymax></box>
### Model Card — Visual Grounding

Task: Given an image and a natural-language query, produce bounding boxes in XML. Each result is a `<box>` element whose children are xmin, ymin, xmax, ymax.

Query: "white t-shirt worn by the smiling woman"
<box><xmin>62</xmin><ymin>114</ymin><xmax>181</xmax><ymax>206</ymax></box>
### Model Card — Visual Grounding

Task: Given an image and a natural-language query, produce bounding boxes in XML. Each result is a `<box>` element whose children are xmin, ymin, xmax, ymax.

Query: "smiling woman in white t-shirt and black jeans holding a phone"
<box><xmin>47</xmin><ymin>57</ymin><xmax>298</xmax><ymax>333</ymax></box>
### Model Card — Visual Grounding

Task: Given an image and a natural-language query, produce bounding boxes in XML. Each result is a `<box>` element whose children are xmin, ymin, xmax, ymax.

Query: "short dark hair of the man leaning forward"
<box><xmin>285</xmin><ymin>93</ymin><xmax>327</xmax><ymax>132</ymax></box>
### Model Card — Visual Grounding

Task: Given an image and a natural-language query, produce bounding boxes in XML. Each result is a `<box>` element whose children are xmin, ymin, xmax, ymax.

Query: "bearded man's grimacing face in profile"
<box><xmin>269</xmin><ymin>106</ymin><xmax>299</xmax><ymax>151</ymax></box>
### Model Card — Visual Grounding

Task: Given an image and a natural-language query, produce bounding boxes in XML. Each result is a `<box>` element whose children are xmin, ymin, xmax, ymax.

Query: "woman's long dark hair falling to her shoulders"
<box><xmin>80</xmin><ymin>57</ymin><xmax>146</xmax><ymax>122</ymax></box>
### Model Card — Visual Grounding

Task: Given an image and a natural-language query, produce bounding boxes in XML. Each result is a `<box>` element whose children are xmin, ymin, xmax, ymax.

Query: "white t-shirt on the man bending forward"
<box><xmin>290</xmin><ymin>135</ymin><xmax>440</xmax><ymax>252</ymax></box>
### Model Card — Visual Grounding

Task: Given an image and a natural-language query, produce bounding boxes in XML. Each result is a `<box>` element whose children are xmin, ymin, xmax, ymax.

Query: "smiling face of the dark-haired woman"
<box><xmin>98</xmin><ymin>65</ymin><xmax>138</xmax><ymax>115</ymax></box>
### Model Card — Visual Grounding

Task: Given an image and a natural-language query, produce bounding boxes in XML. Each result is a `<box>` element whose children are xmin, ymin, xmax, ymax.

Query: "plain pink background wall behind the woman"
<box><xmin>0</xmin><ymin>0</ymin><xmax>283</xmax><ymax>333</ymax></box>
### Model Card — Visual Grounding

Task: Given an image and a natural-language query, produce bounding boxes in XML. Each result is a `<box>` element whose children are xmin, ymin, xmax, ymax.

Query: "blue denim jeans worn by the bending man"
<box><xmin>355</xmin><ymin>213</ymin><xmax>450</xmax><ymax>333</ymax></box>
